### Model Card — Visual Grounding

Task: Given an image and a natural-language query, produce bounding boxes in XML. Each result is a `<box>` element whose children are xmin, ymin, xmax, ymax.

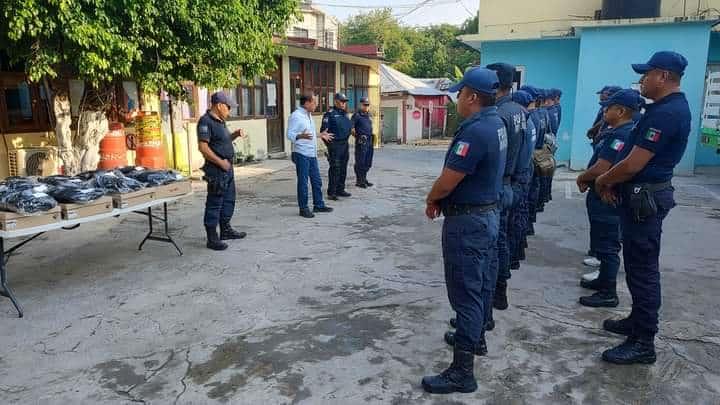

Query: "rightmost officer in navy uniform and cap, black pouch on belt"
<box><xmin>595</xmin><ymin>51</ymin><xmax>691</xmax><ymax>364</ymax></box>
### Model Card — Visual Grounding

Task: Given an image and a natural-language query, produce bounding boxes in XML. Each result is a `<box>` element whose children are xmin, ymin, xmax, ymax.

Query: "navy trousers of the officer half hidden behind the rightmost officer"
<box><xmin>585</xmin><ymin>190</ymin><xmax>620</xmax><ymax>291</ymax></box>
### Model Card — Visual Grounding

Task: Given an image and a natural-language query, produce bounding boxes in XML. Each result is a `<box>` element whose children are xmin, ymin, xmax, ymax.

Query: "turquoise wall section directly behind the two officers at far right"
<box><xmin>570</xmin><ymin>22</ymin><xmax>710</xmax><ymax>174</ymax></box>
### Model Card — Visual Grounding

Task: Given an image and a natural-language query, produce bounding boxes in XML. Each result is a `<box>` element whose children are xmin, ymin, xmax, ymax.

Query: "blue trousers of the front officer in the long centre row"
<box><xmin>442</xmin><ymin>210</ymin><xmax>499</xmax><ymax>352</ymax></box>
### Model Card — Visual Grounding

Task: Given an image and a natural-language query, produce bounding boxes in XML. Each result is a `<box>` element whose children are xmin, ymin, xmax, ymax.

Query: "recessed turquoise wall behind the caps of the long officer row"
<box><xmin>481</xmin><ymin>39</ymin><xmax>580</xmax><ymax>162</ymax></box>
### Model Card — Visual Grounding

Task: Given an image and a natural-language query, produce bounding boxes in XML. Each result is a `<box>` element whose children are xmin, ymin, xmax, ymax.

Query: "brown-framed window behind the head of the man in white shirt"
<box><xmin>290</xmin><ymin>58</ymin><xmax>335</xmax><ymax>113</ymax></box>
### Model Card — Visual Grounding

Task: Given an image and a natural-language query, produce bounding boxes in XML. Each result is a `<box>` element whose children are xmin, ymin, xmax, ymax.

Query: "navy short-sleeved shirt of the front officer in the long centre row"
<box><xmin>442</xmin><ymin>106</ymin><xmax>507</xmax><ymax>206</ymax></box>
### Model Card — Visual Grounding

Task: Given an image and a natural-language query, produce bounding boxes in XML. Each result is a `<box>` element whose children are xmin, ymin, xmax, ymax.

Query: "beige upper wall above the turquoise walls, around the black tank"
<box><xmin>478</xmin><ymin>0</ymin><xmax>720</xmax><ymax>41</ymax></box>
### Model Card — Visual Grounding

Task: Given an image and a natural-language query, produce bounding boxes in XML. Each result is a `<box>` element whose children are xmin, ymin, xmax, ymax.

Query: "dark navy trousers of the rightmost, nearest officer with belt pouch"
<box><xmin>621</xmin><ymin>188</ymin><xmax>675</xmax><ymax>338</ymax></box>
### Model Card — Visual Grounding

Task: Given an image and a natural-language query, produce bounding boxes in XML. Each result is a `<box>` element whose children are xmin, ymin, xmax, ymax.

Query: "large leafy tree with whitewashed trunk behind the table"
<box><xmin>0</xmin><ymin>0</ymin><xmax>298</xmax><ymax>173</ymax></box>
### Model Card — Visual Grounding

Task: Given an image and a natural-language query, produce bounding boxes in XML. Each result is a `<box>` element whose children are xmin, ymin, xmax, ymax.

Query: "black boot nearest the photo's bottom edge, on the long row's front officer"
<box><xmin>422</xmin><ymin>347</ymin><xmax>477</xmax><ymax>394</ymax></box>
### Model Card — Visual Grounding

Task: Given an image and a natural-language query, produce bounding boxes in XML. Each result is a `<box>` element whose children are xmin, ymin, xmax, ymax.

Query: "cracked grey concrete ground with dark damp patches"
<box><xmin>0</xmin><ymin>147</ymin><xmax>720</xmax><ymax>404</ymax></box>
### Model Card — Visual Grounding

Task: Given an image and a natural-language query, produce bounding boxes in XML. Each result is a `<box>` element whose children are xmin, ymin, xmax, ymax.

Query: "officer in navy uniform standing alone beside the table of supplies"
<box><xmin>197</xmin><ymin>91</ymin><xmax>246</xmax><ymax>250</ymax></box>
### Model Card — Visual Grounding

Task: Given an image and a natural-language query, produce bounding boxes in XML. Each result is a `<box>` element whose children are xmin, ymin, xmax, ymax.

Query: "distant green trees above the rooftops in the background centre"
<box><xmin>340</xmin><ymin>8</ymin><xmax>480</xmax><ymax>78</ymax></box>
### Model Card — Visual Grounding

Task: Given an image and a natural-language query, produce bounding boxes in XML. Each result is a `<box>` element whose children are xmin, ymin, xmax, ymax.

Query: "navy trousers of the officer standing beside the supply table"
<box><xmin>203</xmin><ymin>164</ymin><xmax>235</xmax><ymax>227</ymax></box>
